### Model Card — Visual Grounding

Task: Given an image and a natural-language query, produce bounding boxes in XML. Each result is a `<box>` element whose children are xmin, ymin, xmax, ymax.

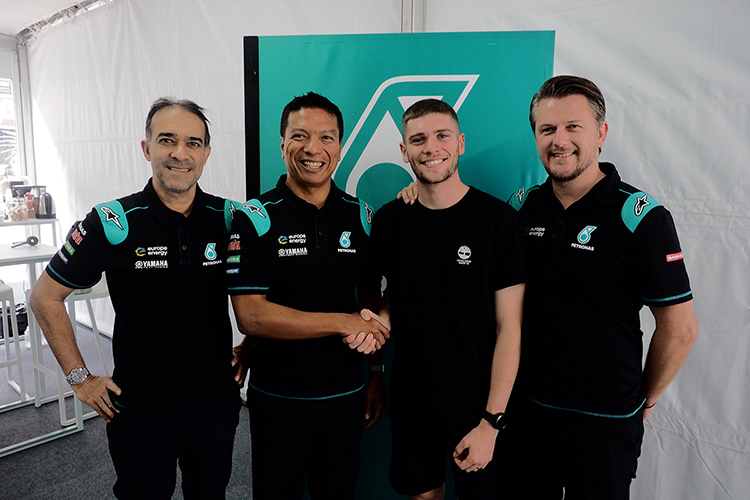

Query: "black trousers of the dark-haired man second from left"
<box><xmin>247</xmin><ymin>389</ymin><xmax>364</xmax><ymax>500</ymax></box>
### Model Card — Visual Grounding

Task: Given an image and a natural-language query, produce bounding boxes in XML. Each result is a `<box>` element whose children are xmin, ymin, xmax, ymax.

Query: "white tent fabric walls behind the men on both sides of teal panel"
<box><xmin>20</xmin><ymin>0</ymin><xmax>750</xmax><ymax>500</ymax></box>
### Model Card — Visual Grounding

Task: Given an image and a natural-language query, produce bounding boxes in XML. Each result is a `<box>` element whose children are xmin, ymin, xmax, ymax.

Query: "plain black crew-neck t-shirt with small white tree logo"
<box><xmin>373</xmin><ymin>188</ymin><xmax>526</xmax><ymax>426</ymax></box>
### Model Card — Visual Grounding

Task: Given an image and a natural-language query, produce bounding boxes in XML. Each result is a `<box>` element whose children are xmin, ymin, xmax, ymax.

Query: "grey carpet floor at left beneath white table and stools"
<box><xmin>0</xmin><ymin>328</ymin><xmax>250</xmax><ymax>500</ymax></box>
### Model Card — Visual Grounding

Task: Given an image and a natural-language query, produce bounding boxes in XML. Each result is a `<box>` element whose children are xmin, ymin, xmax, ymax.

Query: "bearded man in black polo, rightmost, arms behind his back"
<box><xmin>505</xmin><ymin>76</ymin><xmax>698</xmax><ymax>500</ymax></box>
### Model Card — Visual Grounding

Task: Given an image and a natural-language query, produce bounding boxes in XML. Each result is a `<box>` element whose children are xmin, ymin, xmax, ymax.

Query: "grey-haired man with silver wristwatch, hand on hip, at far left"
<box><xmin>30</xmin><ymin>98</ymin><xmax>241</xmax><ymax>499</ymax></box>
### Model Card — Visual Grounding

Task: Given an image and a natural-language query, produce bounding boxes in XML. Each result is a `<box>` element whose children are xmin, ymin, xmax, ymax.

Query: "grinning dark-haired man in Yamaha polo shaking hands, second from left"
<box><xmin>227</xmin><ymin>92</ymin><xmax>388</xmax><ymax>500</ymax></box>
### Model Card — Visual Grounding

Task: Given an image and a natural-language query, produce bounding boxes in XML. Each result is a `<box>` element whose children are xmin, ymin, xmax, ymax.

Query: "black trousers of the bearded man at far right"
<box><xmin>503</xmin><ymin>395</ymin><xmax>643</xmax><ymax>500</ymax></box>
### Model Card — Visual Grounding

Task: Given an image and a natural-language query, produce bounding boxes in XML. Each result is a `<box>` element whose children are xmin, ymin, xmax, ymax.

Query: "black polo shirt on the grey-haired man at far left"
<box><xmin>47</xmin><ymin>180</ymin><xmax>238</xmax><ymax>410</ymax></box>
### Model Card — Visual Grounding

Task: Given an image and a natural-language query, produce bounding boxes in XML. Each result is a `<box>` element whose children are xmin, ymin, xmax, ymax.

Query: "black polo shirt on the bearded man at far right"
<box><xmin>510</xmin><ymin>163</ymin><xmax>692</xmax><ymax>416</ymax></box>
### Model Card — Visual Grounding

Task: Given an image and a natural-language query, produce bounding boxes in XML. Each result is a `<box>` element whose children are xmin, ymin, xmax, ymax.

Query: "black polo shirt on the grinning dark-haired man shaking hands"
<box><xmin>227</xmin><ymin>175</ymin><xmax>380</xmax><ymax>399</ymax></box>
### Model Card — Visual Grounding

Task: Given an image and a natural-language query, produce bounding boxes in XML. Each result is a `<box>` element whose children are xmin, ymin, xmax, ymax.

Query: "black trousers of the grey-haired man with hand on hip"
<box><xmin>107</xmin><ymin>394</ymin><xmax>242</xmax><ymax>500</ymax></box>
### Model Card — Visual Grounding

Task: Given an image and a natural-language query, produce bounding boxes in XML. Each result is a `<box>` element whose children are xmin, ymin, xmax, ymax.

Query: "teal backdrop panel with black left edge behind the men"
<box><xmin>250</xmin><ymin>31</ymin><xmax>555</xmax><ymax>500</ymax></box>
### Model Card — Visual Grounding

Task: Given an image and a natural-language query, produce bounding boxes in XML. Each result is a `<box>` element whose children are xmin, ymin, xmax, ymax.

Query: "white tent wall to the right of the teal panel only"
<box><xmin>425</xmin><ymin>0</ymin><xmax>750</xmax><ymax>500</ymax></box>
